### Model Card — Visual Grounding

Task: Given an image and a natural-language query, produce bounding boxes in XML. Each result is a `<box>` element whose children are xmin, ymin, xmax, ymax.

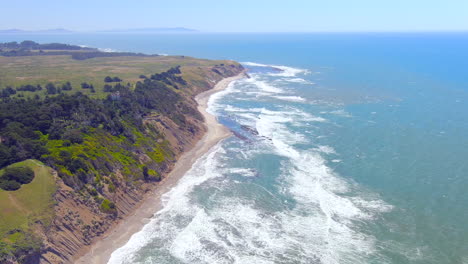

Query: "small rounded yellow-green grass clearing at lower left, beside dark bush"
<box><xmin>0</xmin><ymin>160</ymin><xmax>56</xmax><ymax>248</ymax></box>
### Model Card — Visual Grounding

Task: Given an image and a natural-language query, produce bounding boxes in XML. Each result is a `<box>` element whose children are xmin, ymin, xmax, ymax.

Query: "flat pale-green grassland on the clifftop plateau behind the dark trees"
<box><xmin>0</xmin><ymin>55</ymin><xmax>232</xmax><ymax>98</ymax></box>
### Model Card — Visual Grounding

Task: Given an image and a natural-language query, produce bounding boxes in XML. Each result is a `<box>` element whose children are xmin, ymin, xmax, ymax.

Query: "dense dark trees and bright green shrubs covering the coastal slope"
<box><xmin>0</xmin><ymin>55</ymin><xmax>238</xmax><ymax>196</ymax></box>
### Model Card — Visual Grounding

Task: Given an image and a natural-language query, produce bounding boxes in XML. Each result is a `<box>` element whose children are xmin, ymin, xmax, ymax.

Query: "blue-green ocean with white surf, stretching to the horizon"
<box><xmin>0</xmin><ymin>33</ymin><xmax>468</xmax><ymax>264</ymax></box>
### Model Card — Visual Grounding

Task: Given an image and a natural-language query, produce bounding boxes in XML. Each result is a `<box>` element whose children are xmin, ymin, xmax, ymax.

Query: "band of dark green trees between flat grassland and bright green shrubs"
<box><xmin>0</xmin><ymin>66</ymin><xmax>194</xmax><ymax>188</ymax></box>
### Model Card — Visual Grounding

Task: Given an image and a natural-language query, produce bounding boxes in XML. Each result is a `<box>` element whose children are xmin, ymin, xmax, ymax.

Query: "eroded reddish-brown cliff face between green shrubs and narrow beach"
<box><xmin>37</xmin><ymin>62</ymin><xmax>244</xmax><ymax>263</ymax></box>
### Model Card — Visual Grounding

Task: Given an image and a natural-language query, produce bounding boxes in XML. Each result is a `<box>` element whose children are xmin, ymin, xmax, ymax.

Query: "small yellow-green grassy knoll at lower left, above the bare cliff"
<box><xmin>0</xmin><ymin>160</ymin><xmax>56</xmax><ymax>262</ymax></box>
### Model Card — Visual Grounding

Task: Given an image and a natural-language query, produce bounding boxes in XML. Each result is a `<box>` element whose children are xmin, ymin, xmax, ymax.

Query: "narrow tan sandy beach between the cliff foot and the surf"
<box><xmin>74</xmin><ymin>71</ymin><xmax>245</xmax><ymax>264</ymax></box>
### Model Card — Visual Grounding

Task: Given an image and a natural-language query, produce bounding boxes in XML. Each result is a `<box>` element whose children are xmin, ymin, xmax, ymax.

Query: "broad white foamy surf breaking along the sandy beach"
<box><xmin>110</xmin><ymin>62</ymin><xmax>392</xmax><ymax>264</ymax></box>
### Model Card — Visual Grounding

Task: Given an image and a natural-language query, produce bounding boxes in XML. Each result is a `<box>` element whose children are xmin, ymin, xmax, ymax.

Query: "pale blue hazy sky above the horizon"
<box><xmin>0</xmin><ymin>0</ymin><xmax>468</xmax><ymax>32</ymax></box>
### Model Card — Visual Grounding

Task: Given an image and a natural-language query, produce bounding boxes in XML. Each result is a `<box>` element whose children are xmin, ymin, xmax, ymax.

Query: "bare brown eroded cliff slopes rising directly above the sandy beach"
<box><xmin>41</xmin><ymin>66</ymin><xmax>243</xmax><ymax>263</ymax></box>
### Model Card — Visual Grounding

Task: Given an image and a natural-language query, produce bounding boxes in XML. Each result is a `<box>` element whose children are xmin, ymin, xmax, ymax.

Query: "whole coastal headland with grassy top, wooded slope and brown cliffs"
<box><xmin>0</xmin><ymin>40</ymin><xmax>243</xmax><ymax>263</ymax></box>
